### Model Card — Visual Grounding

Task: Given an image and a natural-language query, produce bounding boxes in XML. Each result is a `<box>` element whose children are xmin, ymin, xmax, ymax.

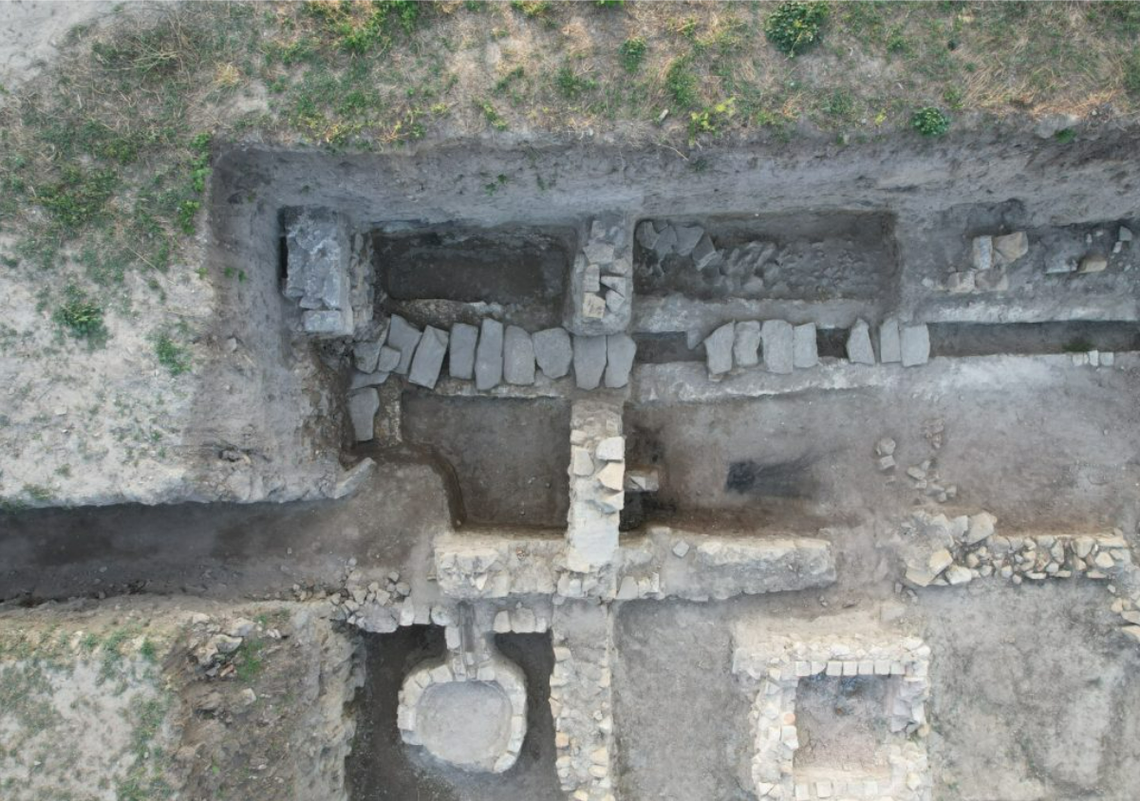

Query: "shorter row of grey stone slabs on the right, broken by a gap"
<box><xmin>705</xmin><ymin>318</ymin><xmax>930</xmax><ymax>376</ymax></box>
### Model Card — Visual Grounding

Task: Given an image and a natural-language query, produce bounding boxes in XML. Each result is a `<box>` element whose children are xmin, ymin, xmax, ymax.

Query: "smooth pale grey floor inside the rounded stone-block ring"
<box><xmin>416</xmin><ymin>681</ymin><xmax>511</xmax><ymax>770</ymax></box>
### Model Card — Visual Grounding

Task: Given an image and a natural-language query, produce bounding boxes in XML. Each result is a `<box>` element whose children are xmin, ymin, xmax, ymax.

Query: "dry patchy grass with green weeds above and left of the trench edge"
<box><xmin>0</xmin><ymin>0</ymin><xmax>1140</xmax><ymax>398</ymax></box>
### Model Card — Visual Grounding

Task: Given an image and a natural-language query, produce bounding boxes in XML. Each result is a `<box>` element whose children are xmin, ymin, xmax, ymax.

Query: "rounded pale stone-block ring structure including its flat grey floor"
<box><xmin>397</xmin><ymin>651</ymin><xmax>527</xmax><ymax>774</ymax></box>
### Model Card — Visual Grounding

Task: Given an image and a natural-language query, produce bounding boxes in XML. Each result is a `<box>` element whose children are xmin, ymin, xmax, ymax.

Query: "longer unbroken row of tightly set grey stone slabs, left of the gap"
<box><xmin>352</xmin><ymin>314</ymin><xmax>637</xmax><ymax>391</ymax></box>
